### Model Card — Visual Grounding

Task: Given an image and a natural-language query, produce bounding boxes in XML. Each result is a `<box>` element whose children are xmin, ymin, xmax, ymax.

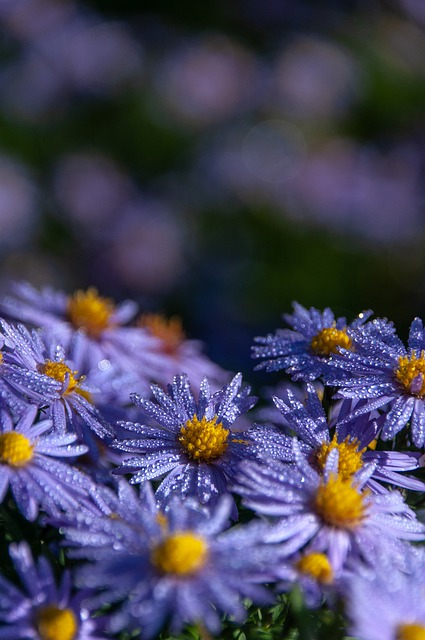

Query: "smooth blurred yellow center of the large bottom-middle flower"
<box><xmin>151</xmin><ymin>531</ymin><xmax>208</xmax><ymax>576</ymax></box>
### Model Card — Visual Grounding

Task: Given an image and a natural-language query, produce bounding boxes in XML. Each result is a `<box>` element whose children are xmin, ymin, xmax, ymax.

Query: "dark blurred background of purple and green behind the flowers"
<box><xmin>0</xmin><ymin>0</ymin><xmax>425</xmax><ymax>378</ymax></box>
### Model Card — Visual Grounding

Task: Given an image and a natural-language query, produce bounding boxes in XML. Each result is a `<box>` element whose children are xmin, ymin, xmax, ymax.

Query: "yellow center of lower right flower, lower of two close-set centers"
<box><xmin>314</xmin><ymin>474</ymin><xmax>365</xmax><ymax>529</ymax></box>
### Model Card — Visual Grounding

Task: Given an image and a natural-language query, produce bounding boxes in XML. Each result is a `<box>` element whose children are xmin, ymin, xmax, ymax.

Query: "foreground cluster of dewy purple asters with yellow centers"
<box><xmin>0</xmin><ymin>283</ymin><xmax>425</xmax><ymax>640</ymax></box>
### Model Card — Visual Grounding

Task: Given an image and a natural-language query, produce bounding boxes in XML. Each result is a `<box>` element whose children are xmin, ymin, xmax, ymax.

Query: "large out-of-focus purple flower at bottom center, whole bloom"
<box><xmin>62</xmin><ymin>483</ymin><xmax>273</xmax><ymax>639</ymax></box>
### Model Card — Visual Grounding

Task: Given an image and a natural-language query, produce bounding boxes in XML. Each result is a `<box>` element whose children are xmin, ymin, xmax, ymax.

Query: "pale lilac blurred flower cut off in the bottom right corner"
<box><xmin>342</xmin><ymin>549</ymin><xmax>425</xmax><ymax>640</ymax></box>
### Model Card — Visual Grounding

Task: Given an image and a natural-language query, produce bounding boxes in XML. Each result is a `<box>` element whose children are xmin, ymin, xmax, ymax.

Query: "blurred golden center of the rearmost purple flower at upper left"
<box><xmin>67</xmin><ymin>287</ymin><xmax>114</xmax><ymax>338</ymax></box>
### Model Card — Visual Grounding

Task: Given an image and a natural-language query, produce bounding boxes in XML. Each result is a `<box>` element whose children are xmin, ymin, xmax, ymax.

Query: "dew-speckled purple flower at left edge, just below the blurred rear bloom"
<box><xmin>0</xmin><ymin>320</ymin><xmax>112</xmax><ymax>441</ymax></box>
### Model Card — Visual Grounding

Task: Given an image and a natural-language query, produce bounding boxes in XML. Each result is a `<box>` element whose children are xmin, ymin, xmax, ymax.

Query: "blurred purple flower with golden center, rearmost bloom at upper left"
<box><xmin>0</xmin><ymin>282</ymin><xmax>156</xmax><ymax>376</ymax></box>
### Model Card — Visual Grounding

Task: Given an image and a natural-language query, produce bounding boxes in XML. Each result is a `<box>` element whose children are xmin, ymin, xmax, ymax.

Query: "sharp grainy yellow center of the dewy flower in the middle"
<box><xmin>179</xmin><ymin>415</ymin><xmax>229</xmax><ymax>462</ymax></box>
